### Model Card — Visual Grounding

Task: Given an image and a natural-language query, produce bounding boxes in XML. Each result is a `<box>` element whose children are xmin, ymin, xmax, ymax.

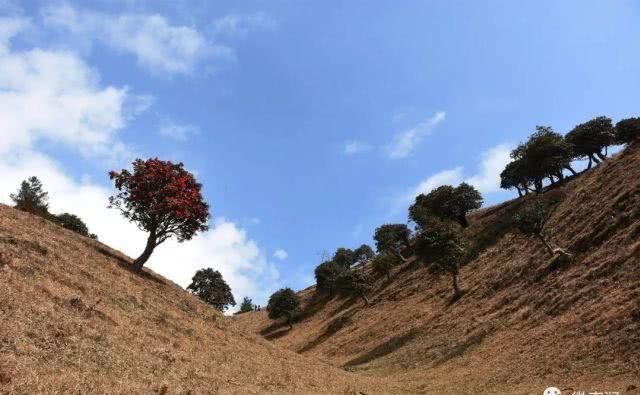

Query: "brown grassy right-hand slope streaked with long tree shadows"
<box><xmin>234</xmin><ymin>144</ymin><xmax>640</xmax><ymax>394</ymax></box>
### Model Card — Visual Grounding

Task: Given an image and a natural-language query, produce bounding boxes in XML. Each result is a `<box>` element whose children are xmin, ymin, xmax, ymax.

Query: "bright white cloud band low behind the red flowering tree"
<box><xmin>0</xmin><ymin>150</ymin><xmax>280</xmax><ymax>308</ymax></box>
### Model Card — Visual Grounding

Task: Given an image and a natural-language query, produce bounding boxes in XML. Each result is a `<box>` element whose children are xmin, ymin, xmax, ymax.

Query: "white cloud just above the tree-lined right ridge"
<box><xmin>404</xmin><ymin>144</ymin><xmax>511</xmax><ymax>203</ymax></box>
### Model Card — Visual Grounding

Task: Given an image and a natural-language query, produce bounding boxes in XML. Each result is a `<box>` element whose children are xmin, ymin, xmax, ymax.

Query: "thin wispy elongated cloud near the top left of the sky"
<box><xmin>43</xmin><ymin>3</ymin><xmax>235</xmax><ymax>74</ymax></box>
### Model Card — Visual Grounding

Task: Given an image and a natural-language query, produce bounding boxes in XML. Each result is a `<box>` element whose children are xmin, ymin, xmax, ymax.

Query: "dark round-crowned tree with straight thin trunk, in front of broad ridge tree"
<box><xmin>415</xmin><ymin>219</ymin><xmax>465</xmax><ymax>298</ymax></box>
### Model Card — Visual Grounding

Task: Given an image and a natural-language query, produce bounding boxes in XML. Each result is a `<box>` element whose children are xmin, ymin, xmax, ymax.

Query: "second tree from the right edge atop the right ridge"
<box><xmin>565</xmin><ymin>116</ymin><xmax>615</xmax><ymax>168</ymax></box>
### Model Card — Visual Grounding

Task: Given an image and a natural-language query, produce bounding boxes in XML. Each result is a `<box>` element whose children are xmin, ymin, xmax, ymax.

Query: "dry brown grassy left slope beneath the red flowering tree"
<box><xmin>0</xmin><ymin>205</ymin><xmax>400</xmax><ymax>394</ymax></box>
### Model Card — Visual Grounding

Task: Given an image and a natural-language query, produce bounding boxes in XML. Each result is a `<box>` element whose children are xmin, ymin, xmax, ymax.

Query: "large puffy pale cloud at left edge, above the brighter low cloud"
<box><xmin>0</xmin><ymin>18</ymin><xmax>134</xmax><ymax>160</ymax></box>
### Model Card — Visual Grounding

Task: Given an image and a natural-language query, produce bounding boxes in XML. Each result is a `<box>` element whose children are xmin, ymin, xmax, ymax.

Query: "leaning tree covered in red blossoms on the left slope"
<box><xmin>109</xmin><ymin>158</ymin><xmax>209</xmax><ymax>271</ymax></box>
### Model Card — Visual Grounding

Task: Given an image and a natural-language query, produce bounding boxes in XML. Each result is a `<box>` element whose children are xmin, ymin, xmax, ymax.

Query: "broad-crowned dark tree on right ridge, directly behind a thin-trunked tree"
<box><xmin>409</xmin><ymin>182</ymin><xmax>482</xmax><ymax>229</ymax></box>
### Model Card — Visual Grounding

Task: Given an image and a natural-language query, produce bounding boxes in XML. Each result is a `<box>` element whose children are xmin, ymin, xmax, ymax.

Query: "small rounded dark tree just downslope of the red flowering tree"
<box><xmin>187</xmin><ymin>268</ymin><xmax>236</xmax><ymax>312</ymax></box>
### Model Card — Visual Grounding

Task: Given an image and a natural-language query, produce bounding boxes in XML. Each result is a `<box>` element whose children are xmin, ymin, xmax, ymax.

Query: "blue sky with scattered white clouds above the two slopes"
<box><xmin>0</xmin><ymin>0</ymin><xmax>640</xmax><ymax>303</ymax></box>
